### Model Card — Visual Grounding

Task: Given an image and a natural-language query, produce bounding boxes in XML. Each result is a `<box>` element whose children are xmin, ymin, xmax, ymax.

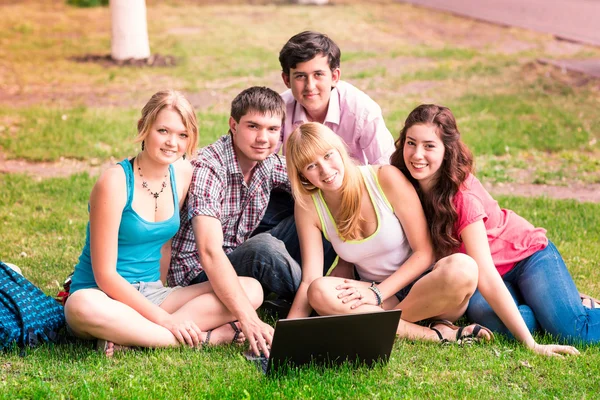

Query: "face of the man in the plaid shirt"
<box><xmin>229</xmin><ymin>112</ymin><xmax>281</xmax><ymax>170</ymax></box>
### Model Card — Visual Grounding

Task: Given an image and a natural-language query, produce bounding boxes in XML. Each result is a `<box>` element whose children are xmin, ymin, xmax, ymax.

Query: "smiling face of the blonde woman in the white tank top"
<box><xmin>300</xmin><ymin>148</ymin><xmax>344</xmax><ymax>192</ymax></box>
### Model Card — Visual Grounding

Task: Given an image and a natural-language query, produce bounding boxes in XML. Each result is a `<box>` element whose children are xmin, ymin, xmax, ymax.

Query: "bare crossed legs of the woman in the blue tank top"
<box><xmin>65</xmin><ymin>277</ymin><xmax>263</xmax><ymax>347</ymax></box>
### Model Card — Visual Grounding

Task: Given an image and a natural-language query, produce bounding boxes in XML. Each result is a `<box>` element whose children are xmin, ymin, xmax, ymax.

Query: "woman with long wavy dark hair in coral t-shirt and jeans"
<box><xmin>391</xmin><ymin>104</ymin><xmax>600</xmax><ymax>355</ymax></box>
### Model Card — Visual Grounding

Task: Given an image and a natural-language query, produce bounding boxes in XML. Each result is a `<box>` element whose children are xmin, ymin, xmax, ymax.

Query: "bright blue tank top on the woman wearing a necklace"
<box><xmin>71</xmin><ymin>159</ymin><xmax>179</xmax><ymax>293</ymax></box>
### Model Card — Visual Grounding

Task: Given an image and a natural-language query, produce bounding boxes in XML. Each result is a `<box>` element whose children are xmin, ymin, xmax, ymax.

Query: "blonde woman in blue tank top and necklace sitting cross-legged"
<box><xmin>65</xmin><ymin>90</ymin><xmax>262</xmax><ymax>356</ymax></box>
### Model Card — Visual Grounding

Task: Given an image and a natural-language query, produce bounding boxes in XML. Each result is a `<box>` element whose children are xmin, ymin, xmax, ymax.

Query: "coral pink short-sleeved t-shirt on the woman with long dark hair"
<box><xmin>454</xmin><ymin>174</ymin><xmax>548</xmax><ymax>275</ymax></box>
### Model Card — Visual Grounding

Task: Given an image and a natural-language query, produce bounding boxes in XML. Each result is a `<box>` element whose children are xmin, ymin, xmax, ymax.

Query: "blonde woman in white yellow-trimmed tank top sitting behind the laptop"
<box><xmin>286</xmin><ymin>122</ymin><xmax>493</xmax><ymax>342</ymax></box>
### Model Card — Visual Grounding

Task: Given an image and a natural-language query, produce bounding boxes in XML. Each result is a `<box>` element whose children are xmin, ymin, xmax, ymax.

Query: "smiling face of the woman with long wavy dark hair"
<box><xmin>403</xmin><ymin>124</ymin><xmax>445</xmax><ymax>191</ymax></box>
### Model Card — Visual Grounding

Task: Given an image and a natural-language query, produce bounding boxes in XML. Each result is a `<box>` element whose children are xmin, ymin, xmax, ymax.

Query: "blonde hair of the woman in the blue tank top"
<box><xmin>134</xmin><ymin>90</ymin><xmax>198</xmax><ymax>157</ymax></box>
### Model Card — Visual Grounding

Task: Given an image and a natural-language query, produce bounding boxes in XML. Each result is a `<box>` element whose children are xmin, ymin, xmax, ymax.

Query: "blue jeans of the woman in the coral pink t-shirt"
<box><xmin>467</xmin><ymin>241</ymin><xmax>600</xmax><ymax>344</ymax></box>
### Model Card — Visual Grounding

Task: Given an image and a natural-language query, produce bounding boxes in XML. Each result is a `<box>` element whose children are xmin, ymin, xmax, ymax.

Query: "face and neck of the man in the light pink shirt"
<box><xmin>282</xmin><ymin>55</ymin><xmax>340</xmax><ymax>123</ymax></box>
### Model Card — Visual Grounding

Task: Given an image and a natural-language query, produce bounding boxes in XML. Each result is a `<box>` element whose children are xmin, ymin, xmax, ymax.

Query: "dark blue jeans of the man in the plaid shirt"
<box><xmin>190</xmin><ymin>233</ymin><xmax>302</xmax><ymax>301</ymax></box>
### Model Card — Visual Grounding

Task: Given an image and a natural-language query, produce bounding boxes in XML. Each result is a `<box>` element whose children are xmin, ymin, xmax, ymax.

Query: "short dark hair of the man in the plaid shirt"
<box><xmin>231</xmin><ymin>86</ymin><xmax>285</xmax><ymax>124</ymax></box>
